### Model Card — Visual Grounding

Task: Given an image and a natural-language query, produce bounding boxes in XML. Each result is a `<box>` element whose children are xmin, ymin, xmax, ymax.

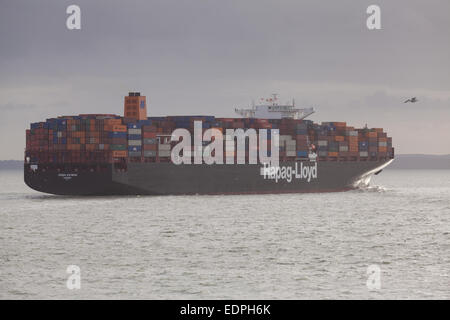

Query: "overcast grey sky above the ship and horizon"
<box><xmin>0</xmin><ymin>0</ymin><xmax>450</xmax><ymax>159</ymax></box>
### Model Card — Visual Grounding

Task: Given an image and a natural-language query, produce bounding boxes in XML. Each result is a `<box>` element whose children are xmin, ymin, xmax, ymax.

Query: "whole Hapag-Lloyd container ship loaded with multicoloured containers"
<box><xmin>24</xmin><ymin>92</ymin><xmax>394</xmax><ymax>195</ymax></box>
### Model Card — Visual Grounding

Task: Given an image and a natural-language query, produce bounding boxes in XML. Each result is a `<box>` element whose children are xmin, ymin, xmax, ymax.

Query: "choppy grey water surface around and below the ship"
<box><xmin>0</xmin><ymin>170</ymin><xmax>450</xmax><ymax>299</ymax></box>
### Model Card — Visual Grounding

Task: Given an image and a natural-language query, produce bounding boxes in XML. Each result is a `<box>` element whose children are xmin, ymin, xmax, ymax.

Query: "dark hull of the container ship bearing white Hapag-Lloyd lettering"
<box><xmin>24</xmin><ymin>161</ymin><xmax>390</xmax><ymax>195</ymax></box>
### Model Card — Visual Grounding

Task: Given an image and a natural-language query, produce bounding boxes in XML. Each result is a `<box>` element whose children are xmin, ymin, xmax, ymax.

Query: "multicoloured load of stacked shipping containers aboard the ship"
<box><xmin>26</xmin><ymin>114</ymin><xmax>394</xmax><ymax>164</ymax></box>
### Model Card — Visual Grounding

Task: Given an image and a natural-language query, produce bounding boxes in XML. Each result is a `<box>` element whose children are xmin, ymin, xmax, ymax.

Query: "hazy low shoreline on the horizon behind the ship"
<box><xmin>0</xmin><ymin>154</ymin><xmax>450</xmax><ymax>170</ymax></box>
